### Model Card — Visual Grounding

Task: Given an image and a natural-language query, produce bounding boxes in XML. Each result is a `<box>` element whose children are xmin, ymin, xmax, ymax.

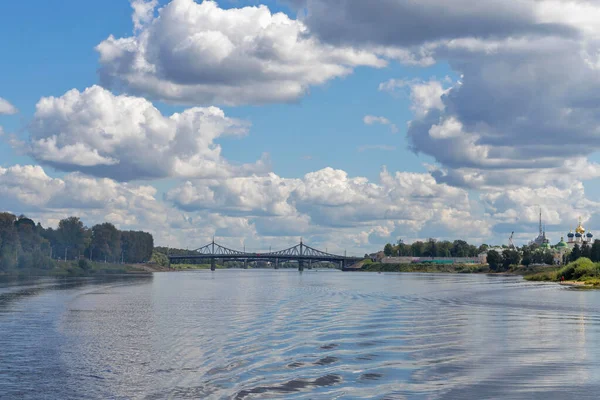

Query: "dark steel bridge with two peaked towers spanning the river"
<box><xmin>168</xmin><ymin>239</ymin><xmax>363</xmax><ymax>271</ymax></box>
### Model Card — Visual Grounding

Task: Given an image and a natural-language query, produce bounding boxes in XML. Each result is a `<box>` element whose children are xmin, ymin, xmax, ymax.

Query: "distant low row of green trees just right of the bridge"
<box><xmin>383</xmin><ymin>239</ymin><xmax>488</xmax><ymax>257</ymax></box>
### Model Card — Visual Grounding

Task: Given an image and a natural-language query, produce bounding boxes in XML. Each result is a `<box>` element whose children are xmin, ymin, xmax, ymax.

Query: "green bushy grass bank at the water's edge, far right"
<box><xmin>524</xmin><ymin>258</ymin><xmax>600</xmax><ymax>287</ymax></box>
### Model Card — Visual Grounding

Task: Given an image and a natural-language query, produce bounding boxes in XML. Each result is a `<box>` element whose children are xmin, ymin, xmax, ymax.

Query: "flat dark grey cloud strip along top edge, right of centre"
<box><xmin>303</xmin><ymin>0</ymin><xmax>574</xmax><ymax>47</ymax></box>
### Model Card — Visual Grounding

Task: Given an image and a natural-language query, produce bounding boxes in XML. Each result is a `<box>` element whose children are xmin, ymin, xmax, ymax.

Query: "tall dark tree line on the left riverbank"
<box><xmin>0</xmin><ymin>212</ymin><xmax>154</xmax><ymax>271</ymax></box>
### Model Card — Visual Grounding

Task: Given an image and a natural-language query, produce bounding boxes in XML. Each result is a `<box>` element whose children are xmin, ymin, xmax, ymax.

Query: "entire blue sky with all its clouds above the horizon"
<box><xmin>0</xmin><ymin>0</ymin><xmax>600</xmax><ymax>255</ymax></box>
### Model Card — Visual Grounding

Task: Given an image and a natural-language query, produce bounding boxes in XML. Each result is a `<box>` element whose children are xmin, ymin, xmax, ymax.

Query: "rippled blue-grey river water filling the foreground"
<box><xmin>0</xmin><ymin>270</ymin><xmax>600</xmax><ymax>400</ymax></box>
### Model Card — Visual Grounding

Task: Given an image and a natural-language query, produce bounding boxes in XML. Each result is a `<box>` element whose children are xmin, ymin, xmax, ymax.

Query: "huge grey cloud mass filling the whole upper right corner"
<box><xmin>294</xmin><ymin>0</ymin><xmax>600</xmax><ymax>186</ymax></box>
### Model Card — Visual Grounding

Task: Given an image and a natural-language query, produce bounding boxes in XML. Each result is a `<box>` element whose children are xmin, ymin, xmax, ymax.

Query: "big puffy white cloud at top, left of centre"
<box><xmin>96</xmin><ymin>0</ymin><xmax>385</xmax><ymax>105</ymax></box>
